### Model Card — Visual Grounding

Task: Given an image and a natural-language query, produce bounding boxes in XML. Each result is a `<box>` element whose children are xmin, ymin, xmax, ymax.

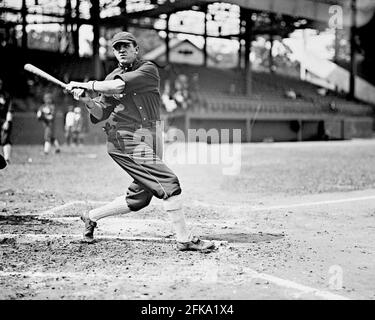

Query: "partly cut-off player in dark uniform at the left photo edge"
<box><xmin>0</xmin><ymin>79</ymin><xmax>13</xmax><ymax>163</ymax></box>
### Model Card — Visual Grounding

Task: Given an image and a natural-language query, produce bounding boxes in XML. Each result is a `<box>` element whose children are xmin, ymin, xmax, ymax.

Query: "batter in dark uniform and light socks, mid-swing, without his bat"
<box><xmin>68</xmin><ymin>32</ymin><xmax>214</xmax><ymax>251</ymax></box>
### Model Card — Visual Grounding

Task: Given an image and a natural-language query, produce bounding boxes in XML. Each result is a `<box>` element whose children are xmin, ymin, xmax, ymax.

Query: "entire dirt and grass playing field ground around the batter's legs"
<box><xmin>0</xmin><ymin>140</ymin><xmax>375</xmax><ymax>299</ymax></box>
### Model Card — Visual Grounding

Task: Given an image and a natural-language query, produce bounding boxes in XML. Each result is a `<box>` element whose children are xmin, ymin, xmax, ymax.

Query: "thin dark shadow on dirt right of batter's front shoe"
<box><xmin>204</xmin><ymin>233</ymin><xmax>285</xmax><ymax>243</ymax></box>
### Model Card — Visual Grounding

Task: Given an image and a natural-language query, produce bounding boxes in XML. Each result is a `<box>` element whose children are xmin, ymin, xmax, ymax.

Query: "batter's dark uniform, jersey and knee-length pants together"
<box><xmin>91</xmin><ymin>60</ymin><xmax>181</xmax><ymax>211</ymax></box>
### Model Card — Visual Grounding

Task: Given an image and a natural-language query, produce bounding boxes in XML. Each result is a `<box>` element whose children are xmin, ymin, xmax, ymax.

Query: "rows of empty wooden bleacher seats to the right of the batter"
<box><xmin>161</xmin><ymin>65</ymin><xmax>374</xmax><ymax>142</ymax></box>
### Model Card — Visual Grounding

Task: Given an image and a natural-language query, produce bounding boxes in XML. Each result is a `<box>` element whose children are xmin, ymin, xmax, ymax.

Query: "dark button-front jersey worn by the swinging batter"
<box><xmin>90</xmin><ymin>60</ymin><xmax>161</xmax><ymax>128</ymax></box>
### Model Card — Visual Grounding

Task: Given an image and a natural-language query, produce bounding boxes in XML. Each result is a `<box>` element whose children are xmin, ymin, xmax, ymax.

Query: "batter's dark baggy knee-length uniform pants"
<box><xmin>107</xmin><ymin>128</ymin><xmax>181</xmax><ymax>211</ymax></box>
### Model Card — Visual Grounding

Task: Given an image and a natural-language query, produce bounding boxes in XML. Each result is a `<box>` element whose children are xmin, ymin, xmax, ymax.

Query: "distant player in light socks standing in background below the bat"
<box><xmin>36</xmin><ymin>93</ymin><xmax>60</xmax><ymax>155</ymax></box>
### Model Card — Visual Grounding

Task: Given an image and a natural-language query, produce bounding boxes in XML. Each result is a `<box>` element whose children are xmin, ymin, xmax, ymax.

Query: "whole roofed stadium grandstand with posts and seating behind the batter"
<box><xmin>0</xmin><ymin>0</ymin><xmax>375</xmax><ymax>144</ymax></box>
